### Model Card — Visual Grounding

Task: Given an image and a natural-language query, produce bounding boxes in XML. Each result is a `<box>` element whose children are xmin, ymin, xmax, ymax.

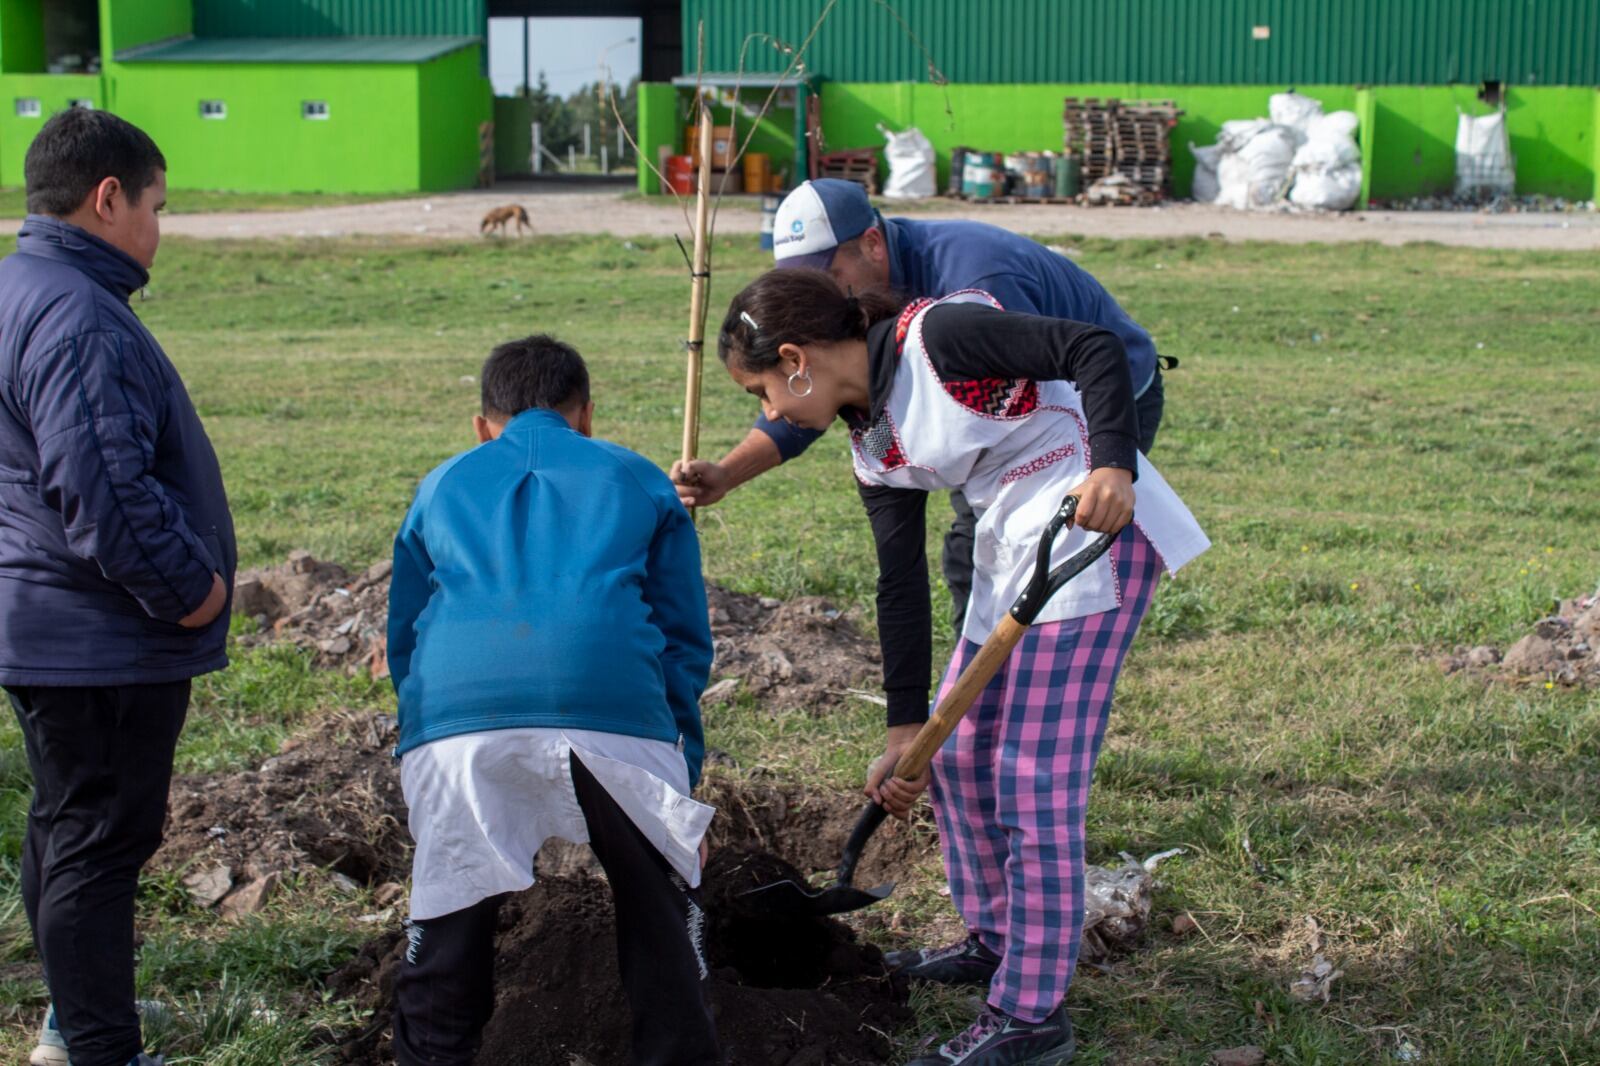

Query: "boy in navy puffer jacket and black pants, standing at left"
<box><xmin>0</xmin><ymin>109</ymin><xmax>235</xmax><ymax>1066</ymax></box>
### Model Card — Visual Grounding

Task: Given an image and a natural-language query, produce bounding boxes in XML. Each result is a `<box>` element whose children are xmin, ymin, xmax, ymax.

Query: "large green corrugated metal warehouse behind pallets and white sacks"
<box><xmin>640</xmin><ymin>0</ymin><xmax>1600</xmax><ymax>202</ymax></box>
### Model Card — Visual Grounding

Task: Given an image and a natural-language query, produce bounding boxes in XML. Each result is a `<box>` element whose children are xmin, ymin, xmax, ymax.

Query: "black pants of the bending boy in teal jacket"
<box><xmin>394</xmin><ymin>755</ymin><xmax>722</xmax><ymax>1066</ymax></box>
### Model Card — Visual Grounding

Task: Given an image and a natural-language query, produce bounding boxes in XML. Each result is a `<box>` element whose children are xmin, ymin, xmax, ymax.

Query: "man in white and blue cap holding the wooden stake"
<box><xmin>672</xmin><ymin>178</ymin><xmax>1176</xmax><ymax>632</ymax></box>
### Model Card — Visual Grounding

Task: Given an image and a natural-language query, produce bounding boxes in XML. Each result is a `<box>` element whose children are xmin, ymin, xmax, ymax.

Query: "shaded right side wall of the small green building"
<box><xmin>411</xmin><ymin>48</ymin><xmax>494</xmax><ymax>189</ymax></box>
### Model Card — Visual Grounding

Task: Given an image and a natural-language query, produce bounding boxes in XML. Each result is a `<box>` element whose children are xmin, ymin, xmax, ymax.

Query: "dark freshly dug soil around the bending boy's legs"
<box><xmin>330</xmin><ymin>850</ymin><xmax>910</xmax><ymax>1066</ymax></box>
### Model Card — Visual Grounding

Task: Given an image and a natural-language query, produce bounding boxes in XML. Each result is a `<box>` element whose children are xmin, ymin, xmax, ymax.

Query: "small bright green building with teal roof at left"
<box><xmin>0</xmin><ymin>0</ymin><xmax>491</xmax><ymax>192</ymax></box>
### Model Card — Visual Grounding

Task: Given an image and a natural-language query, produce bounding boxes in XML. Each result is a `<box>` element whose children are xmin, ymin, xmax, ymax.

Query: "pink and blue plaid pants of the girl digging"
<box><xmin>931</xmin><ymin>525</ymin><xmax>1162</xmax><ymax>1021</ymax></box>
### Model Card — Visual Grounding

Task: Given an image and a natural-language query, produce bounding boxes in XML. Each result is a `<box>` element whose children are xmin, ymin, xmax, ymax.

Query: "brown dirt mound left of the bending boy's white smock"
<box><xmin>154</xmin><ymin>712</ymin><xmax>411</xmax><ymax>889</ymax></box>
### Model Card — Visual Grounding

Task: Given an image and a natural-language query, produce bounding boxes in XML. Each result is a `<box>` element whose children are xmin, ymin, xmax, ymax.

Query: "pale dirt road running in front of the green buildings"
<box><xmin>0</xmin><ymin>182</ymin><xmax>1600</xmax><ymax>251</ymax></box>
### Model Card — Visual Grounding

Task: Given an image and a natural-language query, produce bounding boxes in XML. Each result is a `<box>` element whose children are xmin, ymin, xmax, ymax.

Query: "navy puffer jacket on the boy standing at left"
<box><xmin>0</xmin><ymin>214</ymin><xmax>237</xmax><ymax>685</ymax></box>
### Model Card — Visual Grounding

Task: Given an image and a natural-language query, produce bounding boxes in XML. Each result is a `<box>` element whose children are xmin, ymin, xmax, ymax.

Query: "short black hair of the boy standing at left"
<box><xmin>22</xmin><ymin>107</ymin><xmax>166</xmax><ymax>218</ymax></box>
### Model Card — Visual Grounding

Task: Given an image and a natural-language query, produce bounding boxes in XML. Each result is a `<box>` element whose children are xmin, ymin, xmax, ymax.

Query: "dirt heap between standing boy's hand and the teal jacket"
<box><xmin>234</xmin><ymin>551</ymin><xmax>394</xmax><ymax>679</ymax></box>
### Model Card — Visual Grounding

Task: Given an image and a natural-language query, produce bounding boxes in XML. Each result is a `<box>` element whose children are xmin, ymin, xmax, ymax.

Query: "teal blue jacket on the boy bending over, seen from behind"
<box><xmin>389</xmin><ymin>410</ymin><xmax>712</xmax><ymax>781</ymax></box>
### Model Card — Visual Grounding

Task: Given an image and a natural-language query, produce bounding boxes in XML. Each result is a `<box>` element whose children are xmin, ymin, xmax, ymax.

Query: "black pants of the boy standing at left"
<box><xmin>6</xmin><ymin>680</ymin><xmax>189</xmax><ymax>1066</ymax></box>
